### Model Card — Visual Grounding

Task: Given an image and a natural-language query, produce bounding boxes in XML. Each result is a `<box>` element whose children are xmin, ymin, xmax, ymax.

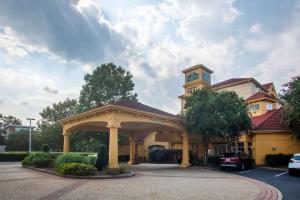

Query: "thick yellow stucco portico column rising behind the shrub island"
<box><xmin>108</xmin><ymin>127</ymin><xmax>119</xmax><ymax>168</ymax></box>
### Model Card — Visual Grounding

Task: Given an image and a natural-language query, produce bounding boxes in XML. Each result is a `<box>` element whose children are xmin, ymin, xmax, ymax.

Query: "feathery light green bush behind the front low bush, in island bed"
<box><xmin>54</xmin><ymin>153</ymin><xmax>94</xmax><ymax>169</ymax></box>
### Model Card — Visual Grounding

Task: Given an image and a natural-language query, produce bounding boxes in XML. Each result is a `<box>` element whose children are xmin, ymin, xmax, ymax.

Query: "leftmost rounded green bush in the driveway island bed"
<box><xmin>22</xmin><ymin>153</ymin><xmax>52</xmax><ymax>167</ymax></box>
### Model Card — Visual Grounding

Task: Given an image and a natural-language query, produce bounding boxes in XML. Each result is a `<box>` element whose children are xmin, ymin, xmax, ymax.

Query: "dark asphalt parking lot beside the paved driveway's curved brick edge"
<box><xmin>223</xmin><ymin>168</ymin><xmax>300</xmax><ymax>200</ymax></box>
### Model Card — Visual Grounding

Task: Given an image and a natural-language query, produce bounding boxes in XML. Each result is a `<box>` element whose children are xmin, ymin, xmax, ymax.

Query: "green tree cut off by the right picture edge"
<box><xmin>280</xmin><ymin>76</ymin><xmax>300</xmax><ymax>140</ymax></box>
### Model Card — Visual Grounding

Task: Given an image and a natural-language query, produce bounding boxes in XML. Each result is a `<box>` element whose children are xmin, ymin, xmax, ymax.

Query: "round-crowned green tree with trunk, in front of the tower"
<box><xmin>183</xmin><ymin>88</ymin><xmax>251</xmax><ymax>163</ymax></box>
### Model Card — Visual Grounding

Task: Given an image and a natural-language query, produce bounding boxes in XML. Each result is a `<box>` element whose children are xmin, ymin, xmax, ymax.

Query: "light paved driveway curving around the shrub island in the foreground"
<box><xmin>0</xmin><ymin>163</ymin><xmax>280</xmax><ymax>200</ymax></box>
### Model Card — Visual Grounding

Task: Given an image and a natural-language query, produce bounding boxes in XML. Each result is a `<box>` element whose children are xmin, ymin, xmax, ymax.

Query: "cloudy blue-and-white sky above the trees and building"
<box><xmin>0</xmin><ymin>0</ymin><xmax>300</xmax><ymax>124</ymax></box>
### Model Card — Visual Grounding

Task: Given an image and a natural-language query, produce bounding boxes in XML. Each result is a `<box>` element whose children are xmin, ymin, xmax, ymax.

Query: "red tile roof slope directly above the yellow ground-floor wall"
<box><xmin>251</xmin><ymin>108</ymin><xmax>287</xmax><ymax>130</ymax></box>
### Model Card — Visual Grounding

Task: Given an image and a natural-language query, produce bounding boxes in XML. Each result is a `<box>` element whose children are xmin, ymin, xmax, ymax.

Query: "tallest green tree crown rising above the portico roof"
<box><xmin>79</xmin><ymin>63</ymin><xmax>137</xmax><ymax>111</ymax></box>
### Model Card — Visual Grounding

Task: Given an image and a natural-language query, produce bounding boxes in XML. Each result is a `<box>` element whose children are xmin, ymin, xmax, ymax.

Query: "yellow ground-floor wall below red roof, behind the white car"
<box><xmin>253</xmin><ymin>132</ymin><xmax>300</xmax><ymax>165</ymax></box>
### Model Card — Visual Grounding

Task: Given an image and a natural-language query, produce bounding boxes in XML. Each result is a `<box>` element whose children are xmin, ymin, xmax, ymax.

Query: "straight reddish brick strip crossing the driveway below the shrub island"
<box><xmin>36</xmin><ymin>180</ymin><xmax>89</xmax><ymax>200</ymax></box>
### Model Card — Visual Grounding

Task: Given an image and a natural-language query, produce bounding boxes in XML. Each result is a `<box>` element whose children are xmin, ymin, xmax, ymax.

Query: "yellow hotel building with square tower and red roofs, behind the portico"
<box><xmin>120</xmin><ymin>65</ymin><xmax>300</xmax><ymax>165</ymax></box>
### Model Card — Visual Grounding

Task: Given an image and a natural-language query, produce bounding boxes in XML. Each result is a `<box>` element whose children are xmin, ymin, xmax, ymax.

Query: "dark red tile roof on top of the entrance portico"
<box><xmin>110</xmin><ymin>100</ymin><xmax>177</xmax><ymax>118</ymax></box>
